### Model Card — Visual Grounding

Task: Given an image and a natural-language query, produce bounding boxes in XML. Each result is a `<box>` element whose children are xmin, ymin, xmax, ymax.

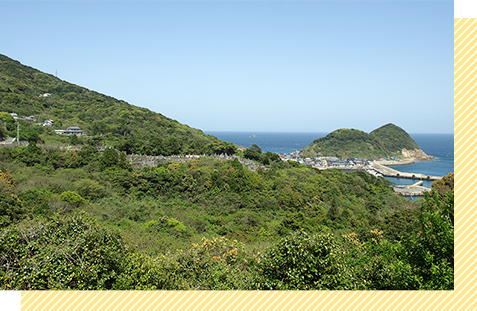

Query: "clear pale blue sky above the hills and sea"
<box><xmin>0</xmin><ymin>0</ymin><xmax>454</xmax><ymax>133</ymax></box>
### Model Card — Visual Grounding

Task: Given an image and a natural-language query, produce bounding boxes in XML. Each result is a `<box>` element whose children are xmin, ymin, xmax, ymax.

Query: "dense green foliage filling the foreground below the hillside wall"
<box><xmin>0</xmin><ymin>140</ymin><xmax>454</xmax><ymax>290</ymax></box>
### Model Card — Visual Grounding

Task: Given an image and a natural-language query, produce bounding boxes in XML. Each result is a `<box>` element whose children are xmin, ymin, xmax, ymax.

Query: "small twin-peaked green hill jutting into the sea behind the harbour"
<box><xmin>301</xmin><ymin>123</ymin><xmax>432</xmax><ymax>160</ymax></box>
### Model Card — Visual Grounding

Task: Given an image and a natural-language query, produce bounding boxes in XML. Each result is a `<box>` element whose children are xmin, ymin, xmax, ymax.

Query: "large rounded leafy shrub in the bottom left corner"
<box><xmin>0</xmin><ymin>215</ymin><xmax>125</xmax><ymax>290</ymax></box>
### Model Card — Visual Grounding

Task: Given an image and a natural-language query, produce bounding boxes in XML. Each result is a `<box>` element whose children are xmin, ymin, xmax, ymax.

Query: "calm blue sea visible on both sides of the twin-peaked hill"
<box><xmin>206</xmin><ymin>131</ymin><xmax>454</xmax><ymax>187</ymax></box>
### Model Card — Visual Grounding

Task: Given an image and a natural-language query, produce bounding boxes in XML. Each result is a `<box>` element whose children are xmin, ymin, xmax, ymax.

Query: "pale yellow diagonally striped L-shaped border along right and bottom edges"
<box><xmin>21</xmin><ymin>19</ymin><xmax>468</xmax><ymax>311</ymax></box>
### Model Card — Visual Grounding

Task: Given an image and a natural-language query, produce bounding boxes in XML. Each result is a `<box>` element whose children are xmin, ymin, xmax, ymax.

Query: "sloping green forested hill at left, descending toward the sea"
<box><xmin>0</xmin><ymin>54</ymin><xmax>229</xmax><ymax>153</ymax></box>
